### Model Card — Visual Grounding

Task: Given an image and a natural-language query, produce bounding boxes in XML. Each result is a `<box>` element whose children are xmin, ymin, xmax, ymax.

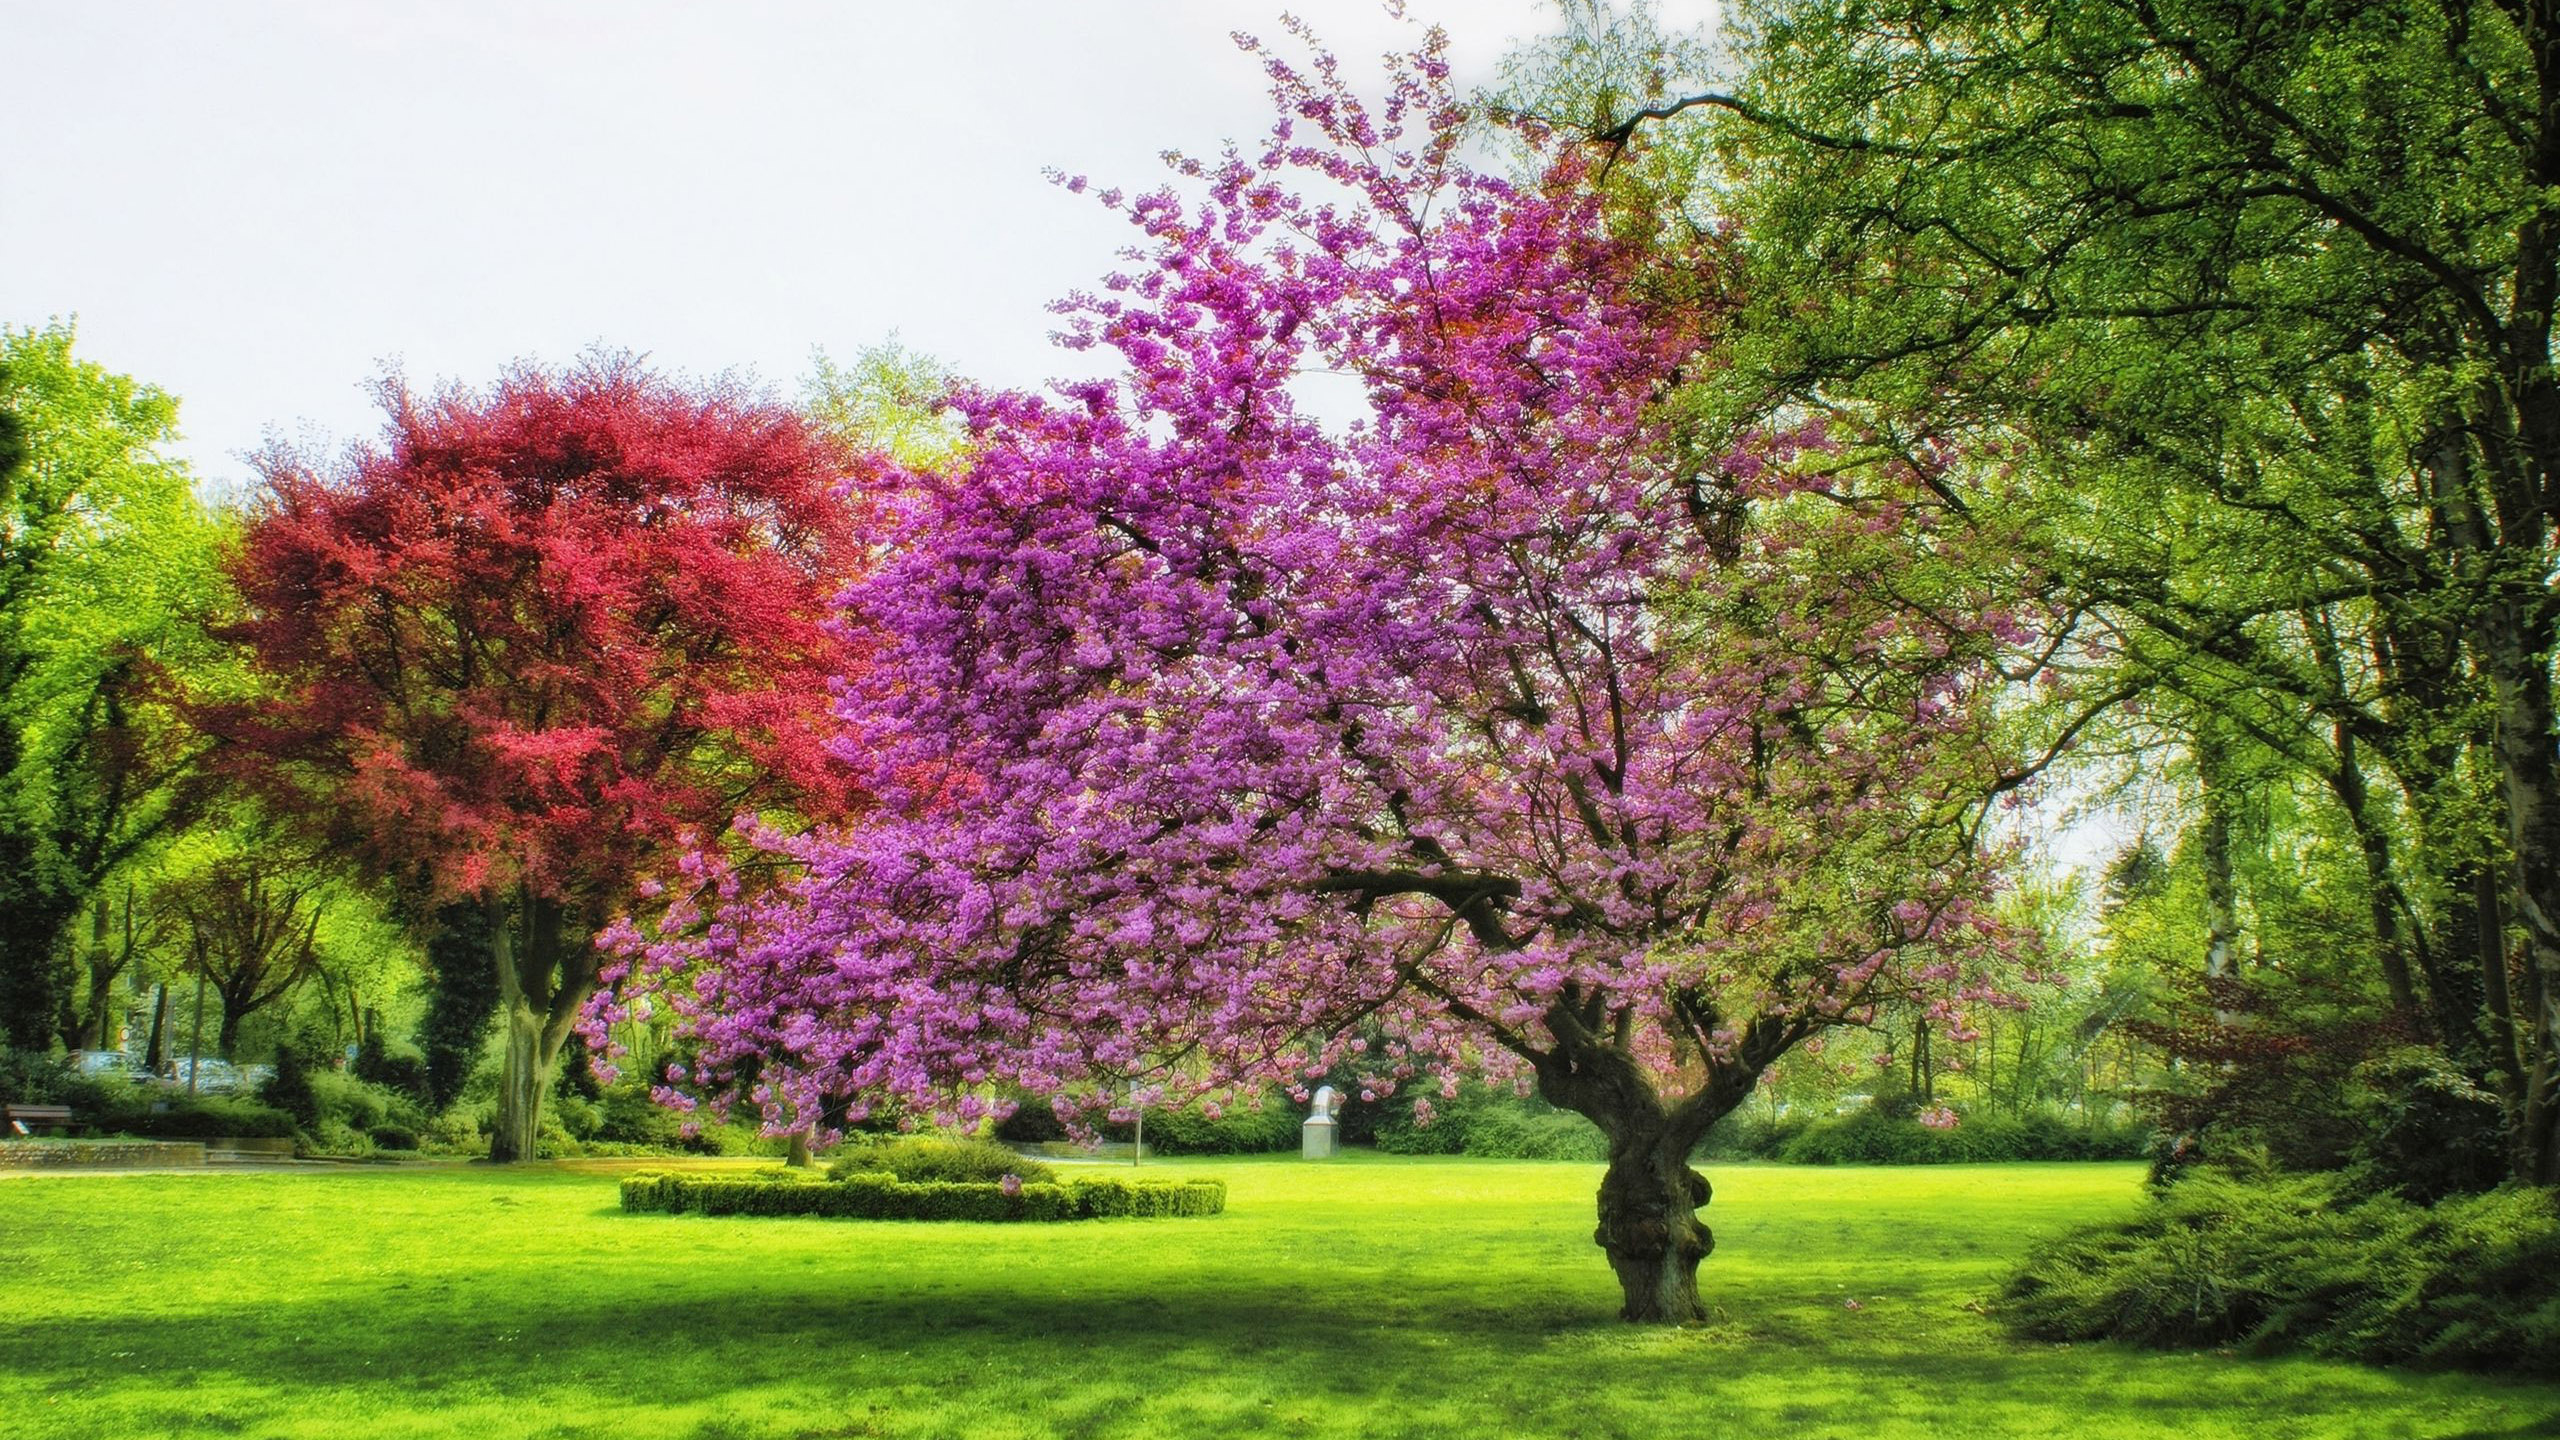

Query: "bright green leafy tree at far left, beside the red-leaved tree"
<box><xmin>0</xmin><ymin>325</ymin><xmax>220</xmax><ymax>1048</ymax></box>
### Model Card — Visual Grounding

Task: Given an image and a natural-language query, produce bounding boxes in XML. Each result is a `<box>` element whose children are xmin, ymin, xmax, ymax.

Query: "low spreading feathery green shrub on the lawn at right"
<box><xmin>1999</xmin><ymin>1168</ymin><xmax>2560</xmax><ymax>1373</ymax></box>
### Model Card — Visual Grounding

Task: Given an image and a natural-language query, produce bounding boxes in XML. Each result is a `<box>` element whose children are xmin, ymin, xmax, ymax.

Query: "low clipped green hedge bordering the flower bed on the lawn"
<box><xmin>622</xmin><ymin>1171</ymin><xmax>1226</xmax><ymax>1220</ymax></box>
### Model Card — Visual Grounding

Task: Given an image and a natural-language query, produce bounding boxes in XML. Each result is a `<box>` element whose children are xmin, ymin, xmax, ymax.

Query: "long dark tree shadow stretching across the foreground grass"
<box><xmin>0</xmin><ymin>1268</ymin><xmax>2560</xmax><ymax>1440</ymax></box>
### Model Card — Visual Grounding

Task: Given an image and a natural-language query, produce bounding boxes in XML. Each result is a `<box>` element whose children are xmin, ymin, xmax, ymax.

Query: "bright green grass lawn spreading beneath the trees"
<box><xmin>0</xmin><ymin>1156</ymin><xmax>2560</xmax><ymax>1440</ymax></box>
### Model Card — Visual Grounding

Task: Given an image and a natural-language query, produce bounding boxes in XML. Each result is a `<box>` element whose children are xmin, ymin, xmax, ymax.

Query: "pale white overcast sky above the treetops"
<box><xmin>0</xmin><ymin>0</ymin><xmax>1710</xmax><ymax>489</ymax></box>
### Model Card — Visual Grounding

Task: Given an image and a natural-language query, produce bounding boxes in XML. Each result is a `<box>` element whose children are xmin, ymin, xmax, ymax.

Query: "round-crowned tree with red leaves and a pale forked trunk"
<box><xmin>202</xmin><ymin>359</ymin><xmax>855</xmax><ymax>1161</ymax></box>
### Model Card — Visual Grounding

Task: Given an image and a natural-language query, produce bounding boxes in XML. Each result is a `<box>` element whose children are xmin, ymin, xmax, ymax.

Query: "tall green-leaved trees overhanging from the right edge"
<box><xmin>1515</xmin><ymin>0</ymin><xmax>2560</xmax><ymax>1181</ymax></box>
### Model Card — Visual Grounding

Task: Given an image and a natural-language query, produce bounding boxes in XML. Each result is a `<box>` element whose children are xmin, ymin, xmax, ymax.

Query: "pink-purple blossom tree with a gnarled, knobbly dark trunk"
<box><xmin>617</xmin><ymin>28</ymin><xmax>2010</xmax><ymax>1322</ymax></box>
